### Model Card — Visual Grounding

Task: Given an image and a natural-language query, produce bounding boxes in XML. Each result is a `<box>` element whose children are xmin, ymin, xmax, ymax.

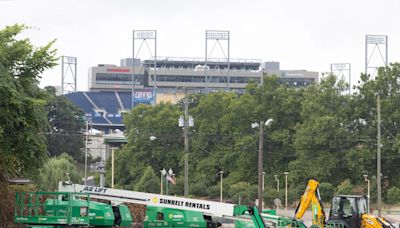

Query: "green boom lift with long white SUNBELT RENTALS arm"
<box><xmin>58</xmin><ymin>181</ymin><xmax>266</xmax><ymax>228</ymax></box>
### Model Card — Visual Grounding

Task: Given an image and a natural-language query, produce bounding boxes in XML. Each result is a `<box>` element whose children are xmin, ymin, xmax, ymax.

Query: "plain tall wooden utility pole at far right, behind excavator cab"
<box><xmin>376</xmin><ymin>91</ymin><xmax>382</xmax><ymax>217</ymax></box>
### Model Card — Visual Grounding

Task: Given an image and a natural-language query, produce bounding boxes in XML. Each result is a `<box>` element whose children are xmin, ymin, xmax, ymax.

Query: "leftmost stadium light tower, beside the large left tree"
<box><xmin>61</xmin><ymin>56</ymin><xmax>77</xmax><ymax>95</ymax></box>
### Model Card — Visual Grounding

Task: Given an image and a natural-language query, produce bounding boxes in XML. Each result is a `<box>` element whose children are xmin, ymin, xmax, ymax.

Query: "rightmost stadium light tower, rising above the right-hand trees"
<box><xmin>365</xmin><ymin>35</ymin><xmax>388</xmax><ymax>78</ymax></box>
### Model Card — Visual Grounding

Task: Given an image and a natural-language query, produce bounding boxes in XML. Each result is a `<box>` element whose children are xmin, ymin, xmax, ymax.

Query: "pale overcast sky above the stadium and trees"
<box><xmin>0</xmin><ymin>0</ymin><xmax>400</xmax><ymax>91</ymax></box>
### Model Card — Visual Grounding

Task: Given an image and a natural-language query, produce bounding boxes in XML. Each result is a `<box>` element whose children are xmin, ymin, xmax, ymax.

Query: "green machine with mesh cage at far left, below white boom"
<box><xmin>14</xmin><ymin>192</ymin><xmax>132</xmax><ymax>228</ymax></box>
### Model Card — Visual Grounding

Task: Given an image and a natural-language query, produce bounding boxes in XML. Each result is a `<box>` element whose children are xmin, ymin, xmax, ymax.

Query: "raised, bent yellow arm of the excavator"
<box><xmin>295</xmin><ymin>179</ymin><xmax>325</xmax><ymax>227</ymax></box>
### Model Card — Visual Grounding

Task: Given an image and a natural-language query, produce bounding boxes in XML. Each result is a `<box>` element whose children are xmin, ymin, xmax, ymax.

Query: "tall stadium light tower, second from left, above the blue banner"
<box><xmin>131</xmin><ymin>30</ymin><xmax>157</xmax><ymax>109</ymax></box>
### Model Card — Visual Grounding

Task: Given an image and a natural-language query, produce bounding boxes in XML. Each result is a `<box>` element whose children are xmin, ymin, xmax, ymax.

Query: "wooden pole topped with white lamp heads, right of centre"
<box><xmin>251</xmin><ymin>119</ymin><xmax>273</xmax><ymax>211</ymax></box>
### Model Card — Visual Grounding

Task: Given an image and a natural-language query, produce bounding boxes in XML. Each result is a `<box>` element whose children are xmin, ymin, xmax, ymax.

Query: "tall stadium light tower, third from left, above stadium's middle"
<box><xmin>204</xmin><ymin>30</ymin><xmax>230</xmax><ymax>93</ymax></box>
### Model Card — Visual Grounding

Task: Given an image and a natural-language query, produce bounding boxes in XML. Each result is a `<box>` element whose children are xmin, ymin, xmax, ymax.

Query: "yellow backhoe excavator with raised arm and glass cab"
<box><xmin>294</xmin><ymin>179</ymin><xmax>394</xmax><ymax>228</ymax></box>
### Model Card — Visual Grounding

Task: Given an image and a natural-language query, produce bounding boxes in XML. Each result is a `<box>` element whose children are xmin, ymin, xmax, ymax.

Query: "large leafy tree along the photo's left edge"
<box><xmin>0</xmin><ymin>25</ymin><xmax>57</xmax><ymax>176</ymax></box>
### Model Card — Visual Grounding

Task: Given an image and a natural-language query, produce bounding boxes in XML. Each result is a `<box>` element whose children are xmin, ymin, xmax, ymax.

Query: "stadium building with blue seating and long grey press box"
<box><xmin>66</xmin><ymin>57</ymin><xmax>318</xmax><ymax>133</ymax></box>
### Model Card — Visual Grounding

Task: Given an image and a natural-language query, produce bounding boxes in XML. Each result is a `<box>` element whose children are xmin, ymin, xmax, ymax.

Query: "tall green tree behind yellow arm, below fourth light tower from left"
<box><xmin>289</xmin><ymin>75</ymin><xmax>357</xmax><ymax>185</ymax></box>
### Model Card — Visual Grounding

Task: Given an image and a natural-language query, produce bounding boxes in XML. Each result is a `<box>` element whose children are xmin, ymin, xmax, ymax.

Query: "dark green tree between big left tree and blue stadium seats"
<box><xmin>45</xmin><ymin>87</ymin><xmax>84</xmax><ymax>162</ymax></box>
